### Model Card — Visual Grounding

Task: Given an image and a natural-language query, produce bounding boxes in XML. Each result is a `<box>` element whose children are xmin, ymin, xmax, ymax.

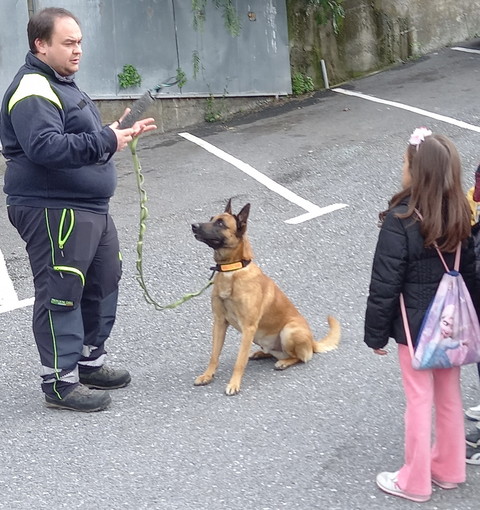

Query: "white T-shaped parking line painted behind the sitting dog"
<box><xmin>178</xmin><ymin>133</ymin><xmax>348</xmax><ymax>224</ymax></box>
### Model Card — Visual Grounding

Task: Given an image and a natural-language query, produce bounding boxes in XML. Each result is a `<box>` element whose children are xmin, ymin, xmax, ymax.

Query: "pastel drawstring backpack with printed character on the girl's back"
<box><xmin>400</xmin><ymin>244</ymin><xmax>480</xmax><ymax>370</ymax></box>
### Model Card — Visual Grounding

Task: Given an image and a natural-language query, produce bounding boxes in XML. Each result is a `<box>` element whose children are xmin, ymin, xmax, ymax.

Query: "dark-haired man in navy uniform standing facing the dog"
<box><xmin>0</xmin><ymin>8</ymin><xmax>156</xmax><ymax>412</ymax></box>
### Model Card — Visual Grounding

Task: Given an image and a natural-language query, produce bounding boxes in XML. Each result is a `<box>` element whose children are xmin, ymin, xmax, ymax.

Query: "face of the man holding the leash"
<box><xmin>35</xmin><ymin>17</ymin><xmax>82</xmax><ymax>76</ymax></box>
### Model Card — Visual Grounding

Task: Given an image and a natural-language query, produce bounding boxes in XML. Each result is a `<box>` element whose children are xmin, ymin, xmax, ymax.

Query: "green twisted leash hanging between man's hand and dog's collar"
<box><xmin>128</xmin><ymin>137</ymin><xmax>215</xmax><ymax>310</ymax></box>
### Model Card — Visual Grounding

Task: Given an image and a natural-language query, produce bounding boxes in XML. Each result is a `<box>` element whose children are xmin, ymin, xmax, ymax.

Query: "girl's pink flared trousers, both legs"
<box><xmin>398</xmin><ymin>344</ymin><xmax>466</xmax><ymax>495</ymax></box>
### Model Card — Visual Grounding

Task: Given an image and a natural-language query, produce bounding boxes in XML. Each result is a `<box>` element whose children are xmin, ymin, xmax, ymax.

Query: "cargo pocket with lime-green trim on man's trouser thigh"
<box><xmin>45</xmin><ymin>266</ymin><xmax>85</xmax><ymax>312</ymax></box>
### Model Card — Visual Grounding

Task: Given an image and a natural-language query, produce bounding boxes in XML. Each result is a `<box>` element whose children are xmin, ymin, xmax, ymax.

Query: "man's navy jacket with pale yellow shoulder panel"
<box><xmin>0</xmin><ymin>52</ymin><xmax>117</xmax><ymax>213</ymax></box>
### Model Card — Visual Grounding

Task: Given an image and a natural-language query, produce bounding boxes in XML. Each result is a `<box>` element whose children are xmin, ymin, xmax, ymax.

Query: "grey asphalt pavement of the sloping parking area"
<box><xmin>0</xmin><ymin>41</ymin><xmax>480</xmax><ymax>510</ymax></box>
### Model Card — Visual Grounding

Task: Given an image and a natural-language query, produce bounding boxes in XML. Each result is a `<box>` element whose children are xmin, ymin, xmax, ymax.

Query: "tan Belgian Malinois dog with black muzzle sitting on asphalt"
<box><xmin>192</xmin><ymin>199</ymin><xmax>341</xmax><ymax>395</ymax></box>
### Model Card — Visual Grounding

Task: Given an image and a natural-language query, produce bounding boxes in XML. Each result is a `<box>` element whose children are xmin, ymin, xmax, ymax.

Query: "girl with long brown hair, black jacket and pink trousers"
<box><xmin>365</xmin><ymin>128</ymin><xmax>475</xmax><ymax>502</ymax></box>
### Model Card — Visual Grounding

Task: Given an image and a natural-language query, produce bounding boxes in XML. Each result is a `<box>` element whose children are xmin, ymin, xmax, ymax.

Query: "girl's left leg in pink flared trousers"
<box><xmin>398</xmin><ymin>345</ymin><xmax>434</xmax><ymax>496</ymax></box>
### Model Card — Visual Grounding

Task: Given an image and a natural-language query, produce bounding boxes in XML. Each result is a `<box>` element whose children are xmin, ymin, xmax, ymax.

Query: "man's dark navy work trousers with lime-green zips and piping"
<box><xmin>8</xmin><ymin>206</ymin><xmax>121</xmax><ymax>398</ymax></box>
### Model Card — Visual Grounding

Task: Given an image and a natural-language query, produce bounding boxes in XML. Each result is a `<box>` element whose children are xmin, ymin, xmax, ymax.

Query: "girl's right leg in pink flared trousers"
<box><xmin>432</xmin><ymin>367</ymin><xmax>466</xmax><ymax>483</ymax></box>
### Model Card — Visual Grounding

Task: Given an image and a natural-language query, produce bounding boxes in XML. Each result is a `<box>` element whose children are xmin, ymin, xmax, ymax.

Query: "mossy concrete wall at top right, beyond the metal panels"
<box><xmin>287</xmin><ymin>0</ymin><xmax>480</xmax><ymax>87</ymax></box>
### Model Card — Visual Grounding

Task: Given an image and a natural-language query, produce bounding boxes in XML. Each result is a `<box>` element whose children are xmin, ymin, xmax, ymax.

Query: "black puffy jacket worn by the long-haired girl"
<box><xmin>365</xmin><ymin>199</ymin><xmax>476</xmax><ymax>349</ymax></box>
